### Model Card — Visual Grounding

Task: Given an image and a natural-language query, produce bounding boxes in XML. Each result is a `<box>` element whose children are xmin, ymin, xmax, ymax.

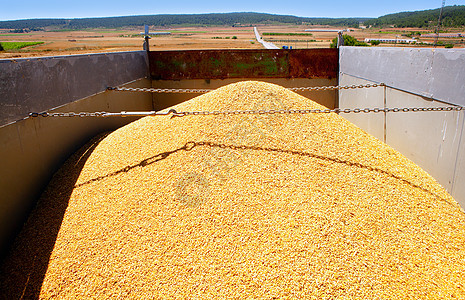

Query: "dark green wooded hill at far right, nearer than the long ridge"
<box><xmin>364</xmin><ymin>5</ymin><xmax>465</xmax><ymax>28</ymax></box>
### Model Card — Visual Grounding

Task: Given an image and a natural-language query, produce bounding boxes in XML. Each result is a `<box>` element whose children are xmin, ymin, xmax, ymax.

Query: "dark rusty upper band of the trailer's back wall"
<box><xmin>149</xmin><ymin>49</ymin><xmax>338</xmax><ymax>80</ymax></box>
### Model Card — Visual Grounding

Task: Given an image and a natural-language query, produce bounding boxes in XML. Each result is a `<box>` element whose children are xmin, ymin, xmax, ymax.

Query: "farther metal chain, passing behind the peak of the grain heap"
<box><xmin>108</xmin><ymin>83</ymin><xmax>385</xmax><ymax>94</ymax></box>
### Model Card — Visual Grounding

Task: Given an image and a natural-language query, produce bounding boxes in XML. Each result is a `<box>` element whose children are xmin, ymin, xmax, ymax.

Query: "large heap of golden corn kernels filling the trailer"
<box><xmin>2</xmin><ymin>81</ymin><xmax>465</xmax><ymax>299</ymax></box>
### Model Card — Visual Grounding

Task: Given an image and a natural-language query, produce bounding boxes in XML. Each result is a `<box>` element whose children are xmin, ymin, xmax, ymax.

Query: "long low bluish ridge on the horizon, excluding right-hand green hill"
<box><xmin>0</xmin><ymin>12</ymin><xmax>369</xmax><ymax>30</ymax></box>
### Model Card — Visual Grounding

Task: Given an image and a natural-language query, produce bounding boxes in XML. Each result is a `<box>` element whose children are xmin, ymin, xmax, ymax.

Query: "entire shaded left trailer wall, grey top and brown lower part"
<box><xmin>0</xmin><ymin>51</ymin><xmax>153</xmax><ymax>256</ymax></box>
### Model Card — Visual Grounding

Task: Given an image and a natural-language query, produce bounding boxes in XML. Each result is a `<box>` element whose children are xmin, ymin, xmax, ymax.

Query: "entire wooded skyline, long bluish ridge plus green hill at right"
<box><xmin>0</xmin><ymin>5</ymin><xmax>465</xmax><ymax>31</ymax></box>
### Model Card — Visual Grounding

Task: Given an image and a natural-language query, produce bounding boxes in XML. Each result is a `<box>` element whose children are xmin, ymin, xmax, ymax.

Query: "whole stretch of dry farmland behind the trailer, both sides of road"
<box><xmin>0</xmin><ymin>25</ymin><xmax>464</xmax><ymax>59</ymax></box>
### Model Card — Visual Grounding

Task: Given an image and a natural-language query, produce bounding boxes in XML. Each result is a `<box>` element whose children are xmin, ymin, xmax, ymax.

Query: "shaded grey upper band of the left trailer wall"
<box><xmin>0</xmin><ymin>51</ymin><xmax>148</xmax><ymax>126</ymax></box>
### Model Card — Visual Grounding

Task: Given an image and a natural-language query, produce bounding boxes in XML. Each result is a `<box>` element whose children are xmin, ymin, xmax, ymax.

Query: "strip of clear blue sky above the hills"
<box><xmin>0</xmin><ymin>0</ymin><xmax>465</xmax><ymax>20</ymax></box>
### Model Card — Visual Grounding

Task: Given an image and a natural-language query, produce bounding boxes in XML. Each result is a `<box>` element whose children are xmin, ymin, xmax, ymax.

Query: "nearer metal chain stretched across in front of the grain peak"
<box><xmin>29</xmin><ymin>106</ymin><xmax>465</xmax><ymax>117</ymax></box>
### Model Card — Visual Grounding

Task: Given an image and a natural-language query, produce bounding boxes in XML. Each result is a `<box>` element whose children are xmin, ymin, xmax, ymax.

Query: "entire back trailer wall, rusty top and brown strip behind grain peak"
<box><xmin>150</xmin><ymin>49</ymin><xmax>339</xmax><ymax>110</ymax></box>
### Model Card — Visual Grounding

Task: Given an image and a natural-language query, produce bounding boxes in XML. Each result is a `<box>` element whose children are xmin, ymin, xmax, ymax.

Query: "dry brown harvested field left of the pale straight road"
<box><xmin>0</xmin><ymin>26</ymin><xmax>262</xmax><ymax>59</ymax></box>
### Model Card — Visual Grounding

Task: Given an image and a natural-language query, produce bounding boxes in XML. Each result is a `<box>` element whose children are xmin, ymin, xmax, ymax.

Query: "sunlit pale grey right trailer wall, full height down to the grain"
<box><xmin>339</xmin><ymin>47</ymin><xmax>465</xmax><ymax>208</ymax></box>
